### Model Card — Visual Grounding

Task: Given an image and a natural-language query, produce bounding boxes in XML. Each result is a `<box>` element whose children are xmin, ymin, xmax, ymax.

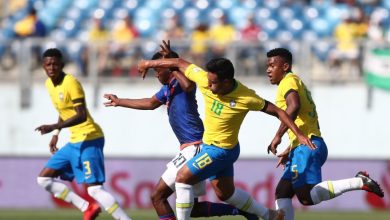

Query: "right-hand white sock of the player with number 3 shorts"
<box><xmin>87</xmin><ymin>185</ymin><xmax>130</xmax><ymax>220</ymax></box>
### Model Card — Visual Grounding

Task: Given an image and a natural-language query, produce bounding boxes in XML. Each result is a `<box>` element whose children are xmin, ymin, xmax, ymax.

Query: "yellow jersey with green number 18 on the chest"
<box><xmin>185</xmin><ymin>64</ymin><xmax>265</xmax><ymax>149</ymax></box>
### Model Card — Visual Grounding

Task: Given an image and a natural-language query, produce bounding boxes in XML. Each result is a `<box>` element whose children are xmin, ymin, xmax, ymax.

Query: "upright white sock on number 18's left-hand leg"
<box><xmin>175</xmin><ymin>183</ymin><xmax>194</xmax><ymax>220</ymax></box>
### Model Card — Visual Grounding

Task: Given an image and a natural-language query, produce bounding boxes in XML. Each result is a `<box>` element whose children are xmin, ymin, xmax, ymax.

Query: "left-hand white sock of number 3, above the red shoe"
<box><xmin>37</xmin><ymin>177</ymin><xmax>89</xmax><ymax>212</ymax></box>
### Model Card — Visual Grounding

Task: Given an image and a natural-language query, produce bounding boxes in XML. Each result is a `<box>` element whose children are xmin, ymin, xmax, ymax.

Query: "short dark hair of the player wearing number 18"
<box><xmin>206</xmin><ymin>58</ymin><xmax>234</xmax><ymax>81</ymax></box>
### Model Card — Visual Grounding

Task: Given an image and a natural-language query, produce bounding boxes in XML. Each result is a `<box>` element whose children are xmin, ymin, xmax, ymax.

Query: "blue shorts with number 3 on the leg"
<box><xmin>45</xmin><ymin>138</ymin><xmax>105</xmax><ymax>184</ymax></box>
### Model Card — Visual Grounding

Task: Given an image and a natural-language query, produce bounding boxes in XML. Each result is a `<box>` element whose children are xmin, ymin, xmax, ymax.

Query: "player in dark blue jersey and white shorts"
<box><xmin>104</xmin><ymin>41</ymin><xmax>258</xmax><ymax>220</ymax></box>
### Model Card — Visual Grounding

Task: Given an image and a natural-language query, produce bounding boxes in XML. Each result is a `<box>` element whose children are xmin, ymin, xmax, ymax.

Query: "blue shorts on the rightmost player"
<box><xmin>282</xmin><ymin>136</ymin><xmax>328</xmax><ymax>189</ymax></box>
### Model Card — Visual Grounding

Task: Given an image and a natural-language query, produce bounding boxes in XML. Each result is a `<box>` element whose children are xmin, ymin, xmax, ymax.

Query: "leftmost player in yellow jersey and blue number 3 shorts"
<box><xmin>35</xmin><ymin>48</ymin><xmax>130</xmax><ymax>220</ymax></box>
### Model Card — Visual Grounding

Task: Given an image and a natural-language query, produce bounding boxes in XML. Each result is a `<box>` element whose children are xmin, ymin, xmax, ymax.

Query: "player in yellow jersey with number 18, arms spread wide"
<box><xmin>138</xmin><ymin>50</ymin><xmax>315</xmax><ymax>220</ymax></box>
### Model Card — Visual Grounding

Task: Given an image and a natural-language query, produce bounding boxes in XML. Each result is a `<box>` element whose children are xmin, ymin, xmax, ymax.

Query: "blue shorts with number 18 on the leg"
<box><xmin>187</xmin><ymin>144</ymin><xmax>240</xmax><ymax>181</ymax></box>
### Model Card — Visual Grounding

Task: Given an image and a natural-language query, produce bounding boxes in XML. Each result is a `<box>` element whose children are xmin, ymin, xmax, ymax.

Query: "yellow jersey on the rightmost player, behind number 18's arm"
<box><xmin>276</xmin><ymin>73</ymin><xmax>321</xmax><ymax>147</ymax></box>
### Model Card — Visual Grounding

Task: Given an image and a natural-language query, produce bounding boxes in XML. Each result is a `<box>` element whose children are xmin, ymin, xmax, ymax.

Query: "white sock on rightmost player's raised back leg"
<box><xmin>310</xmin><ymin>177</ymin><xmax>363</xmax><ymax>204</ymax></box>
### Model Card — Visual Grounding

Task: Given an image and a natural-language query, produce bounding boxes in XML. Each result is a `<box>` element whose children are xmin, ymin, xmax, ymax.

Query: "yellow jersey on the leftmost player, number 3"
<box><xmin>45</xmin><ymin>74</ymin><xmax>103</xmax><ymax>143</ymax></box>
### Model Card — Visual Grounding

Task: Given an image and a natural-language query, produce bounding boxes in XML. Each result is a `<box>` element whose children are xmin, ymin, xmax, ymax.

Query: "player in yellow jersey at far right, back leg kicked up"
<box><xmin>267</xmin><ymin>48</ymin><xmax>383</xmax><ymax>220</ymax></box>
